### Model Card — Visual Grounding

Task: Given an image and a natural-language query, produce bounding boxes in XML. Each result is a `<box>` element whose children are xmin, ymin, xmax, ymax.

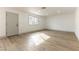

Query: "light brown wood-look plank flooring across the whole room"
<box><xmin>0</xmin><ymin>30</ymin><xmax>79</xmax><ymax>51</ymax></box>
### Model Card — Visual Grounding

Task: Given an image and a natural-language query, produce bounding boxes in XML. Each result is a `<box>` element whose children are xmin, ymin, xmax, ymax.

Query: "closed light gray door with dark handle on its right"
<box><xmin>6</xmin><ymin>12</ymin><xmax>18</xmax><ymax>36</ymax></box>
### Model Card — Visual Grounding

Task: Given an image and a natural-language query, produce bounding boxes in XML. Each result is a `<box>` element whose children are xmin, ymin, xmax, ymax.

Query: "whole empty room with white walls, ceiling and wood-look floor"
<box><xmin>0</xmin><ymin>7</ymin><xmax>79</xmax><ymax>51</ymax></box>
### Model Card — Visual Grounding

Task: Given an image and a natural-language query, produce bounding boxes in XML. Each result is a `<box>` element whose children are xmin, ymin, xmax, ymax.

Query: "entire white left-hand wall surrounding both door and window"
<box><xmin>0</xmin><ymin>8</ymin><xmax>44</xmax><ymax>36</ymax></box>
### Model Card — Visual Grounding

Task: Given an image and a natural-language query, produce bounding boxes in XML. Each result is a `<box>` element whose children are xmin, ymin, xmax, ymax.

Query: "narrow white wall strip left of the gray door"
<box><xmin>0</xmin><ymin>8</ymin><xmax>6</xmax><ymax>37</ymax></box>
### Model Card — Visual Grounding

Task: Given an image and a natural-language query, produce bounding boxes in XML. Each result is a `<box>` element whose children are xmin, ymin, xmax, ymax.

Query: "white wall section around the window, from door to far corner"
<box><xmin>19</xmin><ymin>13</ymin><xmax>45</xmax><ymax>33</ymax></box>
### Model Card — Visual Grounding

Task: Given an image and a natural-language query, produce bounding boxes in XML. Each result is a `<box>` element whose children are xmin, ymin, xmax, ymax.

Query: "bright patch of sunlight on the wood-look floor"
<box><xmin>30</xmin><ymin>33</ymin><xmax>50</xmax><ymax>45</ymax></box>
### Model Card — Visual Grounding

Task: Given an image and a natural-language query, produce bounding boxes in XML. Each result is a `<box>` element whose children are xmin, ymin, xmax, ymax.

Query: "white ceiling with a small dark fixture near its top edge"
<box><xmin>8</xmin><ymin>7</ymin><xmax>76</xmax><ymax>16</ymax></box>
